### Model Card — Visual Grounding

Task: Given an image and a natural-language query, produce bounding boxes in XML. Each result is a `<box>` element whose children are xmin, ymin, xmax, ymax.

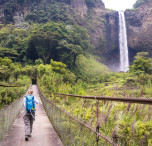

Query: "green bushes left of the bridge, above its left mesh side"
<box><xmin>0</xmin><ymin>57</ymin><xmax>31</xmax><ymax>109</ymax></box>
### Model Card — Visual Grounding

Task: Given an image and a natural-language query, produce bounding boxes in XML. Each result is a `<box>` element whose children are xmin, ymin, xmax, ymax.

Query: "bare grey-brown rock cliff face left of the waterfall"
<box><xmin>69</xmin><ymin>0</ymin><xmax>120</xmax><ymax>69</ymax></box>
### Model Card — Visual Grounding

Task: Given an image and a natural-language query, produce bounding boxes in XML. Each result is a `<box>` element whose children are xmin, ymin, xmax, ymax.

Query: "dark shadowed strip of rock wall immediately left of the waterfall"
<box><xmin>103</xmin><ymin>11</ymin><xmax>120</xmax><ymax>71</ymax></box>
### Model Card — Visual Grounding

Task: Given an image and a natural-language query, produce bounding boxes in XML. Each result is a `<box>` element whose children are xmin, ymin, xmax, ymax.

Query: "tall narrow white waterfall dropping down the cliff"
<box><xmin>118</xmin><ymin>11</ymin><xmax>129</xmax><ymax>72</ymax></box>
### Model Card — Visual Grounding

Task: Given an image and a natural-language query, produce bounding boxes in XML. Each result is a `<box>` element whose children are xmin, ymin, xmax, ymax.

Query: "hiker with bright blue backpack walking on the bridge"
<box><xmin>23</xmin><ymin>90</ymin><xmax>39</xmax><ymax>141</ymax></box>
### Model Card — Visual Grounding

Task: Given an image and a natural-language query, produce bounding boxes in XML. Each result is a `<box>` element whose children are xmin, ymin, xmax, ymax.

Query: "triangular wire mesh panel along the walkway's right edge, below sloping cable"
<box><xmin>38</xmin><ymin>87</ymin><xmax>114</xmax><ymax>146</ymax></box>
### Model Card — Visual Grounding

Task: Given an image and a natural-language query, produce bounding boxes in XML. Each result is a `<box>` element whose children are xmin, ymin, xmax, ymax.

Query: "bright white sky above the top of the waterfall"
<box><xmin>102</xmin><ymin>0</ymin><xmax>137</xmax><ymax>10</ymax></box>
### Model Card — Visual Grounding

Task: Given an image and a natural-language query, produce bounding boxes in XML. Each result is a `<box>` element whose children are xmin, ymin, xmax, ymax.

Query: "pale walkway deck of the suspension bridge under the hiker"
<box><xmin>0</xmin><ymin>85</ymin><xmax>63</xmax><ymax>146</ymax></box>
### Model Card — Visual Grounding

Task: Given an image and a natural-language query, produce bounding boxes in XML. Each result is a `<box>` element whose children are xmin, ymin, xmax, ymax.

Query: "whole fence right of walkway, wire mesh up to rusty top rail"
<box><xmin>37</xmin><ymin>82</ymin><xmax>152</xmax><ymax>146</ymax></box>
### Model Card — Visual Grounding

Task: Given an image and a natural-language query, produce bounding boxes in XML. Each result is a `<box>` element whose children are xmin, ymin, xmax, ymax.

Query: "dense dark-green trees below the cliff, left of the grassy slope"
<box><xmin>0</xmin><ymin>22</ymin><xmax>91</xmax><ymax>68</ymax></box>
